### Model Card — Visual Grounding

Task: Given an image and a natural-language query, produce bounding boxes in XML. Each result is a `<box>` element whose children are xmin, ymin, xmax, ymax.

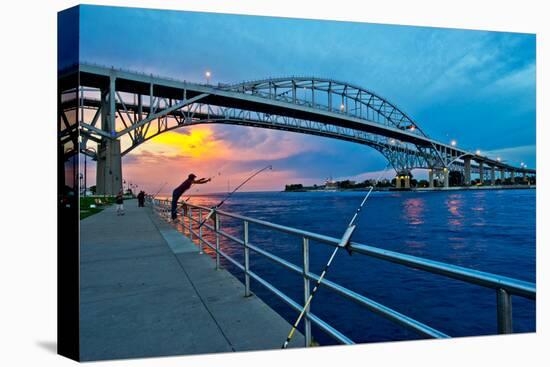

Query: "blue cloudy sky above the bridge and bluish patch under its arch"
<box><xmin>75</xmin><ymin>6</ymin><xmax>536</xmax><ymax>190</ymax></box>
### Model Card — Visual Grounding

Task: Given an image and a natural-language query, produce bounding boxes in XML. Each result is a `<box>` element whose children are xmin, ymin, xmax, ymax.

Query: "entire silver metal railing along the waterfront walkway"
<box><xmin>152</xmin><ymin>199</ymin><xmax>536</xmax><ymax>347</ymax></box>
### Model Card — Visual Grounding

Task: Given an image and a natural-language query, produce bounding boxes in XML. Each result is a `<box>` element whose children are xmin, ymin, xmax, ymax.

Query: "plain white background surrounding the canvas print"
<box><xmin>0</xmin><ymin>0</ymin><xmax>550</xmax><ymax>366</ymax></box>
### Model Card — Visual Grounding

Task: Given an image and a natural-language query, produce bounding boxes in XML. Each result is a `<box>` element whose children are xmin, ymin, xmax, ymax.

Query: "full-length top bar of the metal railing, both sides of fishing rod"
<box><xmin>180</xmin><ymin>204</ymin><xmax>536</xmax><ymax>299</ymax></box>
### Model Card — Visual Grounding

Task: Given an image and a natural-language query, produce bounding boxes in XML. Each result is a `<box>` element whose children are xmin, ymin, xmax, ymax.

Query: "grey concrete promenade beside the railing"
<box><xmin>80</xmin><ymin>200</ymin><xmax>304</xmax><ymax>361</ymax></box>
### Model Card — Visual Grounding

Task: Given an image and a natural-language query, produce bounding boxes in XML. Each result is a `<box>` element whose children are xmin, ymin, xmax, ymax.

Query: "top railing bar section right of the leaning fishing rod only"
<box><xmin>350</xmin><ymin>242</ymin><xmax>537</xmax><ymax>299</ymax></box>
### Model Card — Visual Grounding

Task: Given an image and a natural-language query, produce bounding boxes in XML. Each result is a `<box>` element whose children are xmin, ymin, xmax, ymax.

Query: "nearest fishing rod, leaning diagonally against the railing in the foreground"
<box><xmin>281</xmin><ymin>165</ymin><xmax>389</xmax><ymax>349</ymax></box>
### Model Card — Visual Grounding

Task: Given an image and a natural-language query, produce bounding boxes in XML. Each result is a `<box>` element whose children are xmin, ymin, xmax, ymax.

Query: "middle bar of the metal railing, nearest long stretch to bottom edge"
<box><xmin>248</xmin><ymin>244</ymin><xmax>450</xmax><ymax>338</ymax></box>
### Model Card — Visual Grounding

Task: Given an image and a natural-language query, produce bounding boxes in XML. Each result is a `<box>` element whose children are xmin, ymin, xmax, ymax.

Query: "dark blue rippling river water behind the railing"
<box><xmin>171</xmin><ymin>190</ymin><xmax>536</xmax><ymax>345</ymax></box>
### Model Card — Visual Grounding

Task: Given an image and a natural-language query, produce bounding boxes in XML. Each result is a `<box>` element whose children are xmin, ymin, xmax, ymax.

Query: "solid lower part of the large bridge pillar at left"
<box><xmin>96</xmin><ymin>140</ymin><xmax>122</xmax><ymax>195</ymax></box>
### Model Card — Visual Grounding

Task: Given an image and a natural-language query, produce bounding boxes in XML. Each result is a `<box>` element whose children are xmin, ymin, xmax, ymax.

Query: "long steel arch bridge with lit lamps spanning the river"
<box><xmin>59</xmin><ymin>63</ymin><xmax>536</xmax><ymax>194</ymax></box>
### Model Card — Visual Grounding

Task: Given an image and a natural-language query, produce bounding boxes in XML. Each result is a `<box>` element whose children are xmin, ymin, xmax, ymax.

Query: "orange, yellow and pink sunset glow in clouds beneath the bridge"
<box><xmin>117</xmin><ymin>125</ymin><xmax>324</xmax><ymax>195</ymax></box>
